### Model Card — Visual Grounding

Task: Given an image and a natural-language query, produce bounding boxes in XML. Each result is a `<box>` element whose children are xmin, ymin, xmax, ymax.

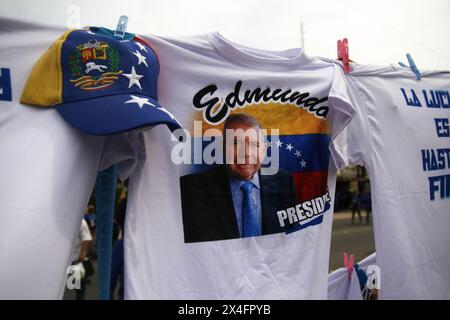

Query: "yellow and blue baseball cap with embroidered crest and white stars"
<box><xmin>20</xmin><ymin>27</ymin><xmax>181</xmax><ymax>135</ymax></box>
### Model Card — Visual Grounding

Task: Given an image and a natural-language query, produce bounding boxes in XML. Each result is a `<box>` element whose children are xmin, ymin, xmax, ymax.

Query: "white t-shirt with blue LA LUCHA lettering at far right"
<box><xmin>334</xmin><ymin>65</ymin><xmax>450</xmax><ymax>299</ymax></box>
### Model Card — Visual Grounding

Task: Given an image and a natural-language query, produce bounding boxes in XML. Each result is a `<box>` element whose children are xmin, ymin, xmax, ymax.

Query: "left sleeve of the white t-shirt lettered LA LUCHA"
<box><xmin>330</xmin><ymin>72</ymin><xmax>370</xmax><ymax>169</ymax></box>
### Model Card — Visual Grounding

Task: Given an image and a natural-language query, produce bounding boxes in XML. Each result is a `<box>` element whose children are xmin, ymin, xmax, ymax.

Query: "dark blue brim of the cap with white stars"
<box><xmin>56</xmin><ymin>94</ymin><xmax>181</xmax><ymax>135</ymax></box>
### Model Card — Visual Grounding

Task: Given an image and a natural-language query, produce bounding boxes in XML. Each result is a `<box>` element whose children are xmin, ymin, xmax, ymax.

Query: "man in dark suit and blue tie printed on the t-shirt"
<box><xmin>180</xmin><ymin>113</ymin><xmax>296</xmax><ymax>242</ymax></box>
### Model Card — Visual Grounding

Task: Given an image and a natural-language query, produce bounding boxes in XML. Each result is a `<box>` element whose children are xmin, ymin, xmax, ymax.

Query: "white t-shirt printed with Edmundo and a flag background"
<box><xmin>116</xmin><ymin>33</ymin><xmax>353</xmax><ymax>299</ymax></box>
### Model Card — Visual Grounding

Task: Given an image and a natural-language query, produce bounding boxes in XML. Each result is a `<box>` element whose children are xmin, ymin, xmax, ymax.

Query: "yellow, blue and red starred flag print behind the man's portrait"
<box><xmin>191</xmin><ymin>103</ymin><xmax>330</xmax><ymax>202</ymax></box>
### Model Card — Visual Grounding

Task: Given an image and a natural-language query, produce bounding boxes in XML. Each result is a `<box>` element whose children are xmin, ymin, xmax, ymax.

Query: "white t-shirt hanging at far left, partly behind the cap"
<box><xmin>0</xmin><ymin>19</ymin><xmax>132</xmax><ymax>299</ymax></box>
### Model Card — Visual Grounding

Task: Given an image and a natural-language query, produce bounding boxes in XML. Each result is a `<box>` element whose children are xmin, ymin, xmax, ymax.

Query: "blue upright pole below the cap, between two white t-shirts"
<box><xmin>95</xmin><ymin>165</ymin><xmax>117</xmax><ymax>300</ymax></box>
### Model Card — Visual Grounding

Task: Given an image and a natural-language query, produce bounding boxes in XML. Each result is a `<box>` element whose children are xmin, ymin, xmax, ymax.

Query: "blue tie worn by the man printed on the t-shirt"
<box><xmin>241</xmin><ymin>181</ymin><xmax>261</xmax><ymax>238</ymax></box>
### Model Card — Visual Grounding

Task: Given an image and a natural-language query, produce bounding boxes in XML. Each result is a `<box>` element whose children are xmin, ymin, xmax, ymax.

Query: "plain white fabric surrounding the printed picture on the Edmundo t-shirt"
<box><xmin>115</xmin><ymin>33</ymin><xmax>353</xmax><ymax>299</ymax></box>
